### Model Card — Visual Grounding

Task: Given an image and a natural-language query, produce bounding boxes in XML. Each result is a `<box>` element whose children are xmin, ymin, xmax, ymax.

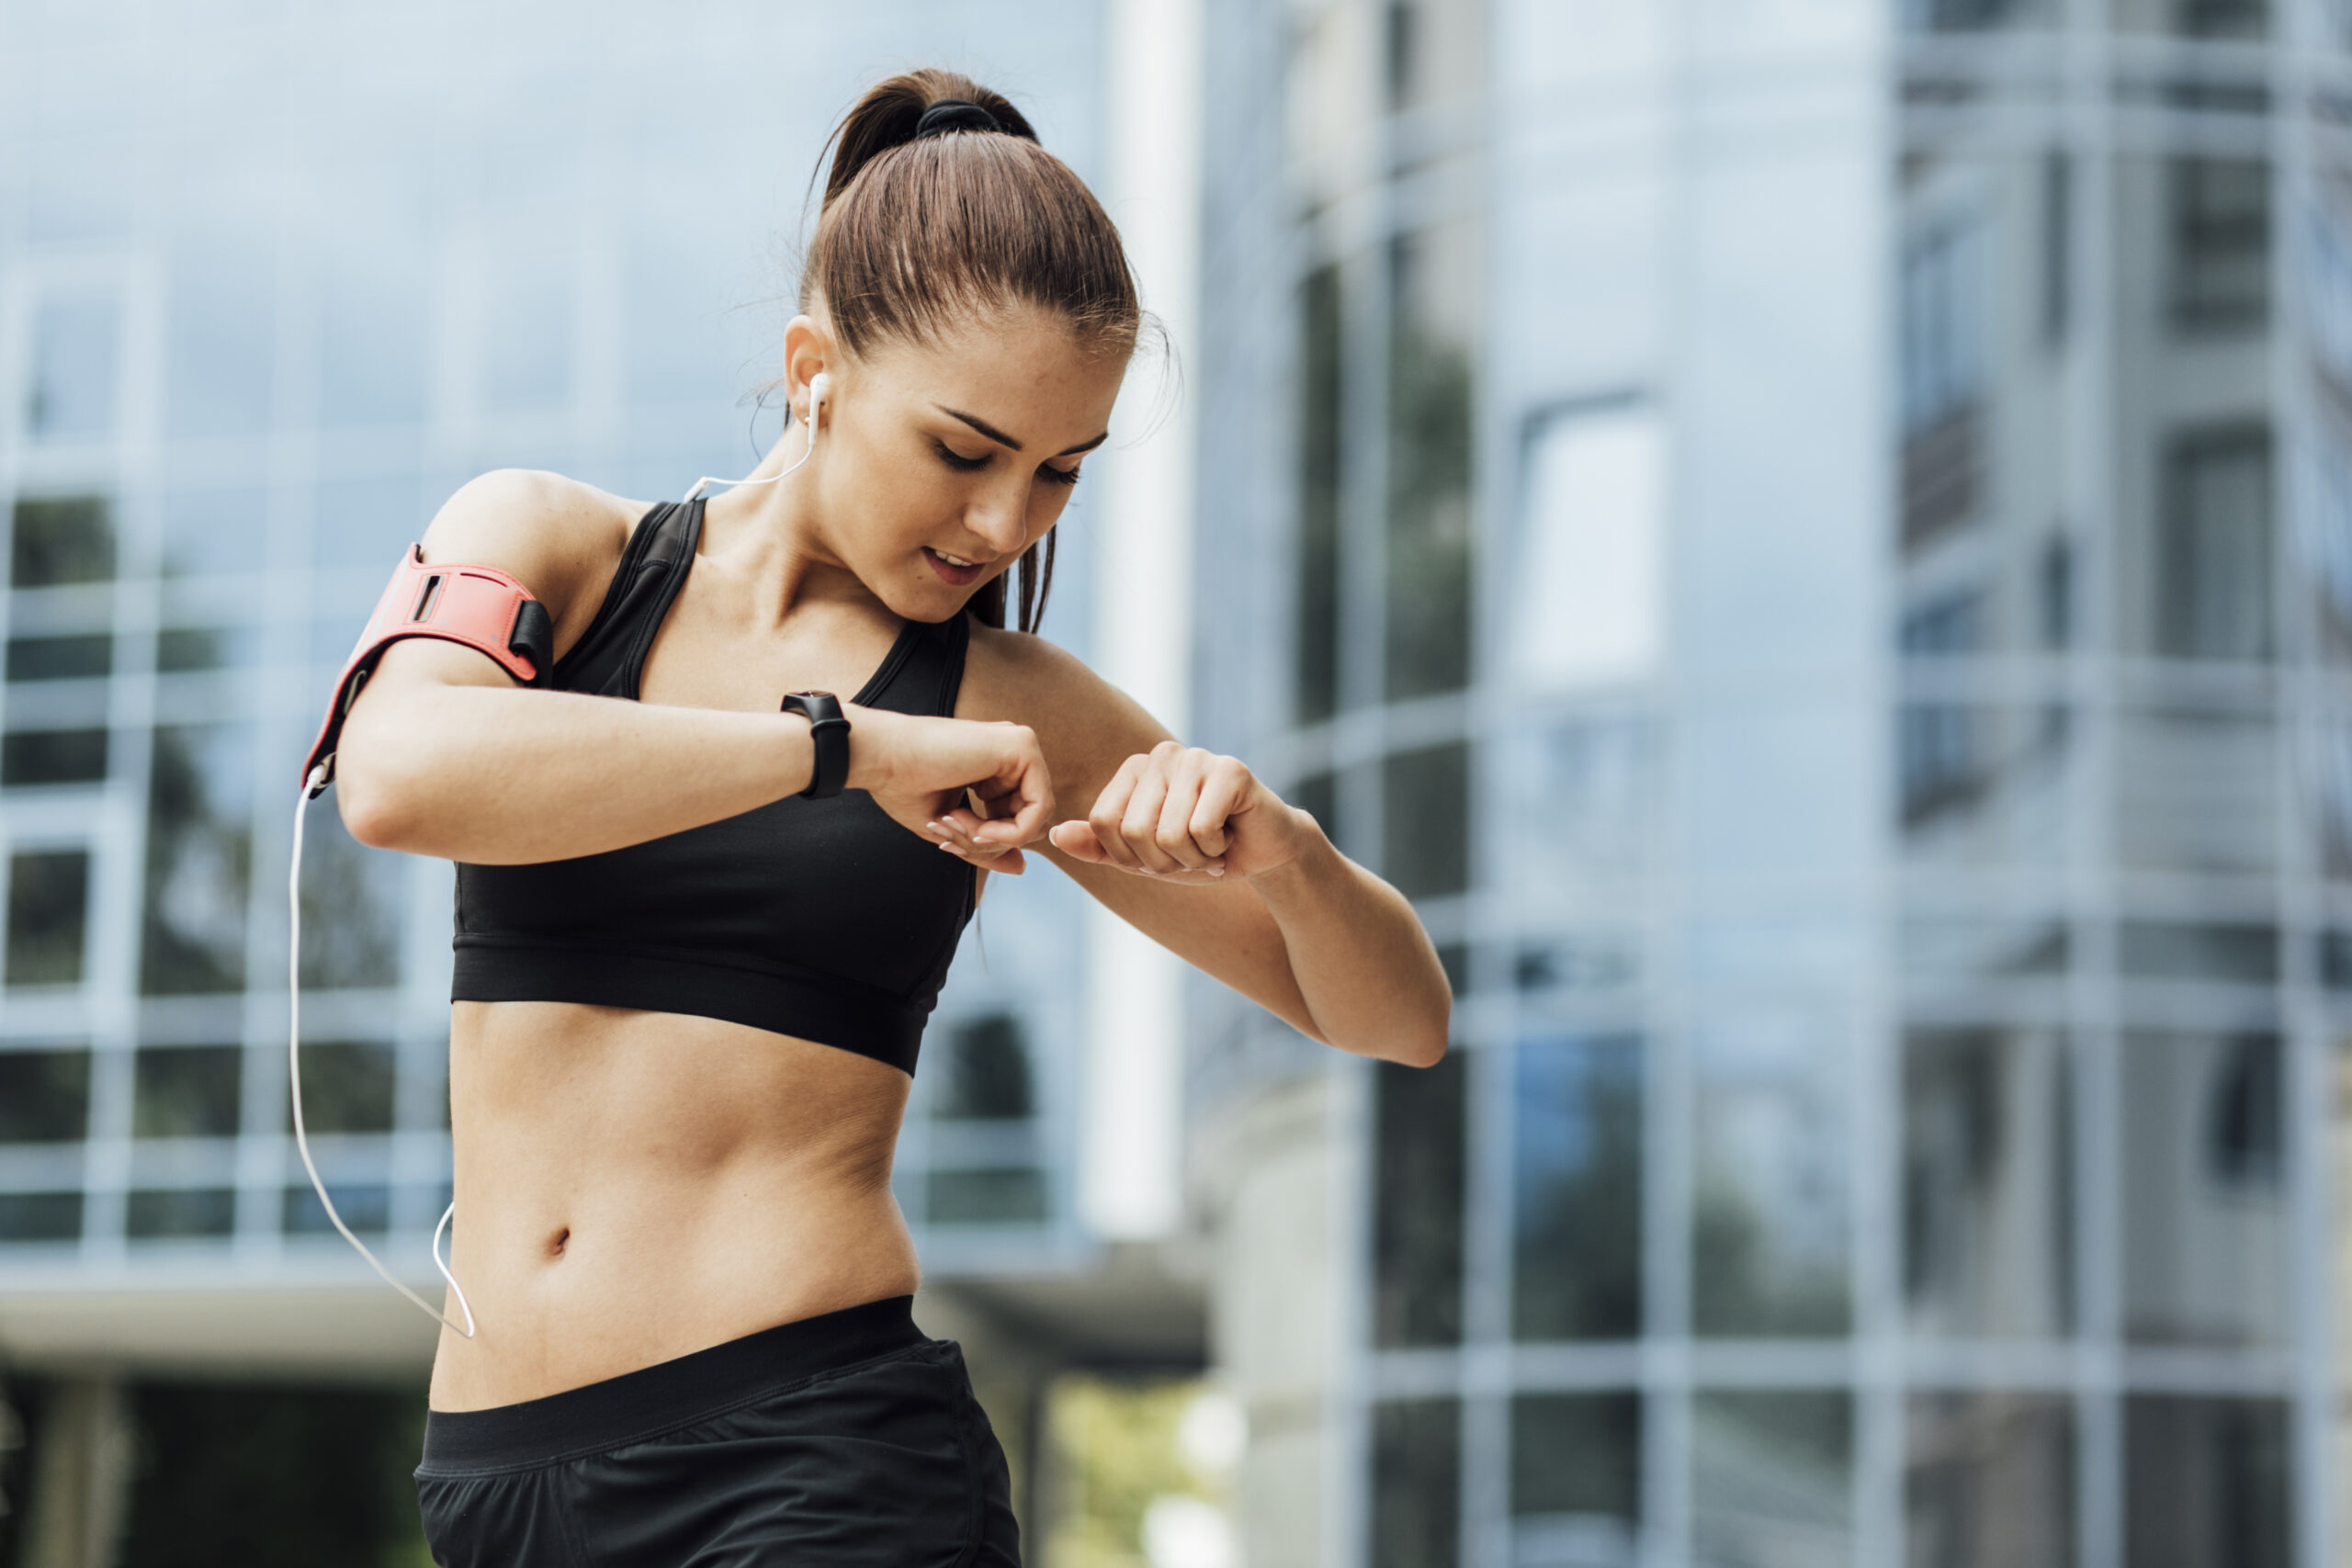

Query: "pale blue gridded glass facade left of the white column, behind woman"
<box><xmin>0</xmin><ymin>5</ymin><xmax>1103</xmax><ymax>1359</ymax></box>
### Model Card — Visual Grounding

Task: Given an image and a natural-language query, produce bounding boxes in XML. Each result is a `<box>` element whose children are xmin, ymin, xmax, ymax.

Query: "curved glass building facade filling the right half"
<box><xmin>1194</xmin><ymin>0</ymin><xmax>2352</xmax><ymax>1568</ymax></box>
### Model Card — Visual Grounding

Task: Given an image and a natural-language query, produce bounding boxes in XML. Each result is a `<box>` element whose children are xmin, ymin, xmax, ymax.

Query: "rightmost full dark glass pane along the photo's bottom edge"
<box><xmin>2124</xmin><ymin>1394</ymin><xmax>2293</xmax><ymax>1568</ymax></box>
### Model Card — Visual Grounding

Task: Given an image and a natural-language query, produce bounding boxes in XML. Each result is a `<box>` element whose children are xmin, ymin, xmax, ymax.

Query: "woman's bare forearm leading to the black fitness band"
<box><xmin>336</xmin><ymin>686</ymin><xmax>814</xmax><ymax>865</ymax></box>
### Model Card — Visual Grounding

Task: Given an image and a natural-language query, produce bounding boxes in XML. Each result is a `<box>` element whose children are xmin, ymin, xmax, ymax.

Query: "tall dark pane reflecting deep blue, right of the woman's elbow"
<box><xmin>1512</xmin><ymin>1034</ymin><xmax>1642</xmax><ymax>1340</ymax></box>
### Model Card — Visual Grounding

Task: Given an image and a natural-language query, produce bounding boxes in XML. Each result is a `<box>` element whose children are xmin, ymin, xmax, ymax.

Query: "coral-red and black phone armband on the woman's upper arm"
<box><xmin>301</xmin><ymin>546</ymin><xmax>555</xmax><ymax>795</ymax></box>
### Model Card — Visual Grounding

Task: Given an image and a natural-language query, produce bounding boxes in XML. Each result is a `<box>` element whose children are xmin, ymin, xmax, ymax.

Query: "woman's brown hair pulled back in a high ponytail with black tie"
<box><xmin>799</xmin><ymin>71</ymin><xmax>1143</xmax><ymax>632</ymax></box>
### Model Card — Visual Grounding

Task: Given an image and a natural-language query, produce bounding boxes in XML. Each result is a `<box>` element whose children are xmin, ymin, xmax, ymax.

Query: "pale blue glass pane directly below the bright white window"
<box><xmin>1498</xmin><ymin>715</ymin><xmax>1660</xmax><ymax>909</ymax></box>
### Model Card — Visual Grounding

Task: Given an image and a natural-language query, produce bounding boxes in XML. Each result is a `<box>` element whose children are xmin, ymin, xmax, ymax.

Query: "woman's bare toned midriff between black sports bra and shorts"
<box><xmin>430</xmin><ymin>1001</ymin><xmax>917</xmax><ymax>1411</ymax></box>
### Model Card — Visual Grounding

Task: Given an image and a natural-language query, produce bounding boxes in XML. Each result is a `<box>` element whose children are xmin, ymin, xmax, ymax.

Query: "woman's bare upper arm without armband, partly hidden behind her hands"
<box><xmin>957</xmin><ymin>627</ymin><xmax>1322</xmax><ymax>1039</ymax></box>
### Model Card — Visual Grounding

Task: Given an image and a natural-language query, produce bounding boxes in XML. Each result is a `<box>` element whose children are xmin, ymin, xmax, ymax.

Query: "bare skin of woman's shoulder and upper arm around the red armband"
<box><xmin>336</xmin><ymin>468</ymin><xmax>630</xmax><ymax>811</ymax></box>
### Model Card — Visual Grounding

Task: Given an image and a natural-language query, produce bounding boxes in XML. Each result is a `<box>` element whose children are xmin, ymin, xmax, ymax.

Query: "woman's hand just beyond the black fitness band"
<box><xmin>842</xmin><ymin>703</ymin><xmax>1054</xmax><ymax>877</ymax></box>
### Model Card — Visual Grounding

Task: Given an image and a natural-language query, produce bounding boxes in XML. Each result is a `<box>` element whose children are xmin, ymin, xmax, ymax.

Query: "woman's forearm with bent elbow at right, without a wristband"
<box><xmin>1249</xmin><ymin>832</ymin><xmax>1453</xmax><ymax>1067</ymax></box>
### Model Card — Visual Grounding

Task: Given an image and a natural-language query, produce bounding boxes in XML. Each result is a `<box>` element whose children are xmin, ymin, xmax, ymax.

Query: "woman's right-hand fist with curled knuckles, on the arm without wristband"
<box><xmin>1046</xmin><ymin>740</ymin><xmax>1317</xmax><ymax>884</ymax></box>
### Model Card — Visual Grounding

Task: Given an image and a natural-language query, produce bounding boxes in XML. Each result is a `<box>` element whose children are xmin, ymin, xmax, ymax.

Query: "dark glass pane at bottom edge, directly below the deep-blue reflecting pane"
<box><xmin>1510</xmin><ymin>1392</ymin><xmax>1642</xmax><ymax>1568</ymax></box>
